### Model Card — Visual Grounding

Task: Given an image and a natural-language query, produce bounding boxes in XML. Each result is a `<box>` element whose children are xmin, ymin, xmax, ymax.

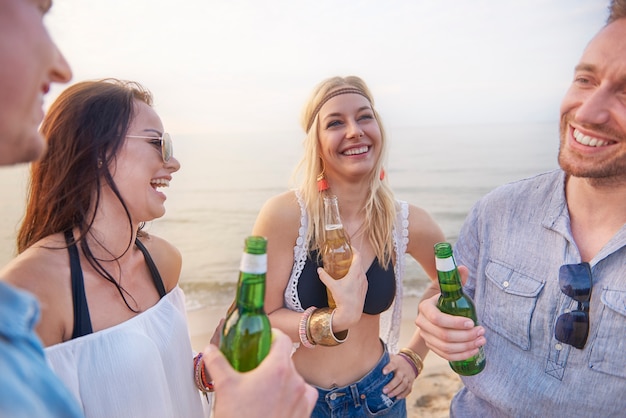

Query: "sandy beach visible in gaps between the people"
<box><xmin>187</xmin><ymin>298</ymin><xmax>462</xmax><ymax>418</ymax></box>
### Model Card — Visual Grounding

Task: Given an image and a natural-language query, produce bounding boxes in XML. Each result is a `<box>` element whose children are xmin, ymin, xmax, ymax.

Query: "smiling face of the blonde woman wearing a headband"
<box><xmin>318</xmin><ymin>93</ymin><xmax>382</xmax><ymax>181</ymax></box>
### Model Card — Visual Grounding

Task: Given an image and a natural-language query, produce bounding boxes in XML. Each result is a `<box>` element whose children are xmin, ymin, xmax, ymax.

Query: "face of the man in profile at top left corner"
<box><xmin>0</xmin><ymin>0</ymin><xmax>72</xmax><ymax>164</ymax></box>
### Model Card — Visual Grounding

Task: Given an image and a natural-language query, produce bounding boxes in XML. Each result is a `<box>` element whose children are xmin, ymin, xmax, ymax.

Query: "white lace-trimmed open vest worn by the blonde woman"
<box><xmin>284</xmin><ymin>191</ymin><xmax>409</xmax><ymax>354</ymax></box>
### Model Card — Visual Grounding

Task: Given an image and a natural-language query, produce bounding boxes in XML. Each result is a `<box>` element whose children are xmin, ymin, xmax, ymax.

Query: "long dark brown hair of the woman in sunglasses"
<box><xmin>17</xmin><ymin>79</ymin><xmax>152</xmax><ymax>310</ymax></box>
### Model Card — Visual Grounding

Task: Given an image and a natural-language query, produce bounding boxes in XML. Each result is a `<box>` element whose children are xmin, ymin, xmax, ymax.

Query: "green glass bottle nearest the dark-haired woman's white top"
<box><xmin>220</xmin><ymin>236</ymin><xmax>272</xmax><ymax>372</ymax></box>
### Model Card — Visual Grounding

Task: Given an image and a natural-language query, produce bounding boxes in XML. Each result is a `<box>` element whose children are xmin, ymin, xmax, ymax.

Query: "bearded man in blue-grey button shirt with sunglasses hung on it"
<box><xmin>416</xmin><ymin>0</ymin><xmax>626</xmax><ymax>418</ymax></box>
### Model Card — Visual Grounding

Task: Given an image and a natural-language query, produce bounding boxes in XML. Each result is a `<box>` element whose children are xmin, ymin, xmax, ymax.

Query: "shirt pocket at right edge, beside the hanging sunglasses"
<box><xmin>589</xmin><ymin>288</ymin><xmax>626</xmax><ymax>378</ymax></box>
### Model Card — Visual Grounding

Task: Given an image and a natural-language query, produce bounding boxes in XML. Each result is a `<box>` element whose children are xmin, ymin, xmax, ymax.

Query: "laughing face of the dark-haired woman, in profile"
<box><xmin>111</xmin><ymin>100</ymin><xmax>180</xmax><ymax>222</ymax></box>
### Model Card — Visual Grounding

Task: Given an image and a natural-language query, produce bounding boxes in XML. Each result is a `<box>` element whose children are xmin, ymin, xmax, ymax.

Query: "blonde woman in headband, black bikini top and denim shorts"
<box><xmin>253</xmin><ymin>77</ymin><xmax>444</xmax><ymax>417</ymax></box>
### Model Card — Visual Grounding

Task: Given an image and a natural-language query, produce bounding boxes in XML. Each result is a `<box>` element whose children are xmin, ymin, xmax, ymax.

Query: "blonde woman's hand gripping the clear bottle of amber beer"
<box><xmin>317</xmin><ymin>250</ymin><xmax>367</xmax><ymax>331</ymax></box>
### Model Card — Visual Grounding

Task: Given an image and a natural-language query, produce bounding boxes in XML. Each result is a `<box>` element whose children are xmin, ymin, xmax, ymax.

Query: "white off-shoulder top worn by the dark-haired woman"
<box><xmin>45</xmin><ymin>286</ymin><xmax>209</xmax><ymax>418</ymax></box>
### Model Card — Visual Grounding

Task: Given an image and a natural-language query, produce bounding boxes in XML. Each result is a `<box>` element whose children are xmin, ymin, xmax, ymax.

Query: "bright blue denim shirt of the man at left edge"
<box><xmin>0</xmin><ymin>282</ymin><xmax>83</xmax><ymax>418</ymax></box>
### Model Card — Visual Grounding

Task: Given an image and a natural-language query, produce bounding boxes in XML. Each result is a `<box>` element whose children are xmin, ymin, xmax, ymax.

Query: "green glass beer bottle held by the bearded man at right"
<box><xmin>435</xmin><ymin>242</ymin><xmax>486</xmax><ymax>376</ymax></box>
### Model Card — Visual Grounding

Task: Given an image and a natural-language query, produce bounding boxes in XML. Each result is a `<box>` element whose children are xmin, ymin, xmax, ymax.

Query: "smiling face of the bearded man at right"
<box><xmin>559</xmin><ymin>19</ymin><xmax>626</xmax><ymax>181</ymax></box>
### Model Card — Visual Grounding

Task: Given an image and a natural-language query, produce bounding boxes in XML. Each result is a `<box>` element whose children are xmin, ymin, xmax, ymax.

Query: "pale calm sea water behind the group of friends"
<box><xmin>0</xmin><ymin>122</ymin><xmax>558</xmax><ymax>309</ymax></box>
